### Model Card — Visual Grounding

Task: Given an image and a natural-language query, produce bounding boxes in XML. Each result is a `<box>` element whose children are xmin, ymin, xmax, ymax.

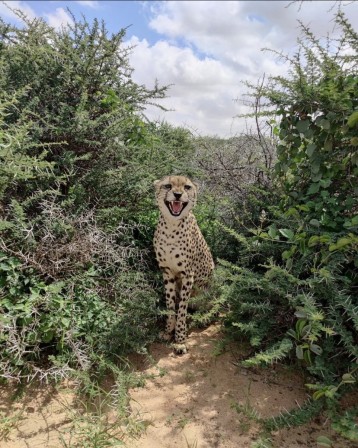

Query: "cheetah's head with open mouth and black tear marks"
<box><xmin>154</xmin><ymin>176</ymin><xmax>197</xmax><ymax>220</ymax></box>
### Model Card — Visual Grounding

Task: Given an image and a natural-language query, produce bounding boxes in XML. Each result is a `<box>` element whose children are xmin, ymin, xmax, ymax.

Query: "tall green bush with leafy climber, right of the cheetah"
<box><xmin>221</xmin><ymin>12</ymin><xmax>358</xmax><ymax>434</ymax></box>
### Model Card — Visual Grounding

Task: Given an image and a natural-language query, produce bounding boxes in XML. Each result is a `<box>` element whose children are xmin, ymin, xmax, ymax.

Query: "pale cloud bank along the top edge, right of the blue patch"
<box><xmin>146</xmin><ymin>1</ymin><xmax>358</xmax><ymax>74</ymax></box>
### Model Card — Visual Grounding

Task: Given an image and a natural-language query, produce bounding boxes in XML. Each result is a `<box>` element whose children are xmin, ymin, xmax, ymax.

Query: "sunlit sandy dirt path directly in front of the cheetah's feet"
<box><xmin>128</xmin><ymin>326</ymin><xmax>347</xmax><ymax>448</ymax></box>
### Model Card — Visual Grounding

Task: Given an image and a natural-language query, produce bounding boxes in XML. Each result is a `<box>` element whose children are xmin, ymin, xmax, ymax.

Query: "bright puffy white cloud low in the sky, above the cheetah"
<box><xmin>130</xmin><ymin>38</ymin><xmax>246</xmax><ymax>135</ymax></box>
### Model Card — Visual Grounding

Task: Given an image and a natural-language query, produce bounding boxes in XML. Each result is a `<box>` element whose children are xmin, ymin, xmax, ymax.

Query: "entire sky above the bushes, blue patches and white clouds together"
<box><xmin>0</xmin><ymin>0</ymin><xmax>358</xmax><ymax>137</ymax></box>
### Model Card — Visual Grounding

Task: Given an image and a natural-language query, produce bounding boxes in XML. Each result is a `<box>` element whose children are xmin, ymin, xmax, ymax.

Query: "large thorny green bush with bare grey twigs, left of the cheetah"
<box><xmin>0</xmin><ymin>13</ymin><xmax>194</xmax><ymax>379</ymax></box>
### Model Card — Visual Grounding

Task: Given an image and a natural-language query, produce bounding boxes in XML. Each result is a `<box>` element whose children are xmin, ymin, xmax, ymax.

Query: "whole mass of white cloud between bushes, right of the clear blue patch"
<box><xmin>131</xmin><ymin>1</ymin><xmax>358</xmax><ymax>136</ymax></box>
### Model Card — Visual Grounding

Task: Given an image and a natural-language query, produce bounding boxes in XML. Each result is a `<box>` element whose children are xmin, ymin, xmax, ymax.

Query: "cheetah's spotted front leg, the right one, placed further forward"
<box><xmin>174</xmin><ymin>275</ymin><xmax>194</xmax><ymax>354</ymax></box>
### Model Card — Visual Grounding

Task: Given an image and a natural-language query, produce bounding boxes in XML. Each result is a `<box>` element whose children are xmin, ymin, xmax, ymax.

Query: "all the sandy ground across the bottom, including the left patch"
<box><xmin>0</xmin><ymin>325</ymin><xmax>358</xmax><ymax>448</ymax></box>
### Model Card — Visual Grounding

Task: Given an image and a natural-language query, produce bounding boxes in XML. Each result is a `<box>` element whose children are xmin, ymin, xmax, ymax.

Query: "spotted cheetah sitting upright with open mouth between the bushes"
<box><xmin>154</xmin><ymin>176</ymin><xmax>214</xmax><ymax>354</ymax></box>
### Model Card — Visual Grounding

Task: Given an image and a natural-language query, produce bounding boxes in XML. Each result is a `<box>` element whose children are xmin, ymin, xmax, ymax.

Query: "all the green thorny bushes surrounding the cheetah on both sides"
<box><xmin>0</xmin><ymin>5</ymin><xmax>358</xmax><ymax>446</ymax></box>
